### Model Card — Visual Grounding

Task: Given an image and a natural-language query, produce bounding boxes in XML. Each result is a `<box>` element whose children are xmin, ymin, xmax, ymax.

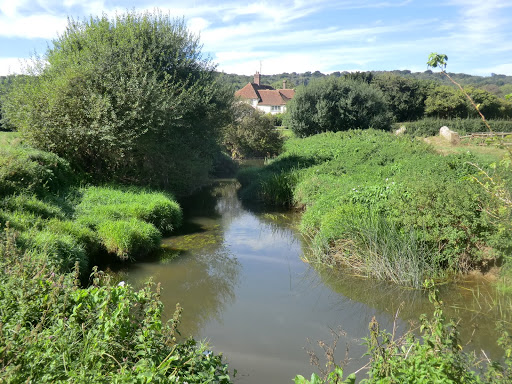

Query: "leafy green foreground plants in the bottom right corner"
<box><xmin>295</xmin><ymin>281</ymin><xmax>512</xmax><ymax>384</ymax></box>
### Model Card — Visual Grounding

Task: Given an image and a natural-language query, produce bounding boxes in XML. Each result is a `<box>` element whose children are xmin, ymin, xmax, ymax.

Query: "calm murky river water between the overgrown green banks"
<box><xmin>119</xmin><ymin>180</ymin><xmax>508</xmax><ymax>383</ymax></box>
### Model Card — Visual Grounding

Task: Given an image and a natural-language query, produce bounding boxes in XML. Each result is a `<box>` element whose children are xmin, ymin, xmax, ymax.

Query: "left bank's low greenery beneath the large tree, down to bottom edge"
<box><xmin>0</xmin><ymin>132</ymin><xmax>230</xmax><ymax>383</ymax></box>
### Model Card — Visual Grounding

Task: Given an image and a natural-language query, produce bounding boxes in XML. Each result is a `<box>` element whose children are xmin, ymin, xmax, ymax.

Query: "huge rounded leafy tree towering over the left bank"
<box><xmin>4</xmin><ymin>12</ymin><xmax>231</xmax><ymax>192</ymax></box>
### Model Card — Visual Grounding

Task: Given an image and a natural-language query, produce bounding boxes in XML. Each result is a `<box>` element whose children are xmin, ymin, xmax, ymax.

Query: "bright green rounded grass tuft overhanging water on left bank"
<box><xmin>97</xmin><ymin>219</ymin><xmax>161</xmax><ymax>260</ymax></box>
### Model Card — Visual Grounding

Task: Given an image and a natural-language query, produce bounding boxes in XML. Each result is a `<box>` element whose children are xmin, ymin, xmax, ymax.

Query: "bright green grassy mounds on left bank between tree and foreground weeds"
<box><xmin>0</xmin><ymin>133</ymin><xmax>181</xmax><ymax>275</ymax></box>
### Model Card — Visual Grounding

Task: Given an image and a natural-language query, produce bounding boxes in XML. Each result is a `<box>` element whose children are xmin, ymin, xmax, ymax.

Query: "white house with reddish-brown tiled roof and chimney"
<box><xmin>235</xmin><ymin>72</ymin><xmax>295</xmax><ymax>115</ymax></box>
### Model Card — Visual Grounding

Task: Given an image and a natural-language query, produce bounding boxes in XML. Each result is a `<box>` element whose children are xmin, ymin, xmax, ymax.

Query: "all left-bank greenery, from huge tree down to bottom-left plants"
<box><xmin>0</xmin><ymin>12</ymin><xmax>236</xmax><ymax>383</ymax></box>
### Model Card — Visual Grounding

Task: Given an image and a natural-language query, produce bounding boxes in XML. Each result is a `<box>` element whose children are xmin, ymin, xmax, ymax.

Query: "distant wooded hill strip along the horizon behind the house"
<box><xmin>219</xmin><ymin>70</ymin><xmax>512</xmax><ymax>97</ymax></box>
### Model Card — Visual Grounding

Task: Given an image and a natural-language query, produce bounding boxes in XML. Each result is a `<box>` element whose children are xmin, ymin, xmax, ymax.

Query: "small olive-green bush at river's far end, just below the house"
<box><xmin>222</xmin><ymin>103</ymin><xmax>283</xmax><ymax>159</ymax></box>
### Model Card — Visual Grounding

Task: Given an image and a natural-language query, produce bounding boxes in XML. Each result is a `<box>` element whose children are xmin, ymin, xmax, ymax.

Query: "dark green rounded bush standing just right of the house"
<box><xmin>288</xmin><ymin>77</ymin><xmax>392</xmax><ymax>137</ymax></box>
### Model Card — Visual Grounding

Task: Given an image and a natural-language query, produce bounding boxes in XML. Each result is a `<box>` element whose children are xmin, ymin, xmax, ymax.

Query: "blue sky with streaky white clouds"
<box><xmin>0</xmin><ymin>0</ymin><xmax>512</xmax><ymax>76</ymax></box>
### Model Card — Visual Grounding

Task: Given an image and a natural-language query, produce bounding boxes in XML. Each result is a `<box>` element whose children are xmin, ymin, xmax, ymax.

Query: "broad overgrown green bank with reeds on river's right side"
<box><xmin>239</xmin><ymin>130</ymin><xmax>512</xmax><ymax>287</ymax></box>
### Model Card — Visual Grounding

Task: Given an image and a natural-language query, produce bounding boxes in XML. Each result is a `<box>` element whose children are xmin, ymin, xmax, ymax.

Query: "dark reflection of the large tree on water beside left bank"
<box><xmin>125</xmin><ymin>182</ymin><xmax>241</xmax><ymax>337</ymax></box>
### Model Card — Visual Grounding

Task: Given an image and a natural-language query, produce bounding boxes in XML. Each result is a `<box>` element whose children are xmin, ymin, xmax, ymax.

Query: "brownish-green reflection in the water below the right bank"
<box><xmin>316</xmin><ymin>267</ymin><xmax>503</xmax><ymax>359</ymax></box>
